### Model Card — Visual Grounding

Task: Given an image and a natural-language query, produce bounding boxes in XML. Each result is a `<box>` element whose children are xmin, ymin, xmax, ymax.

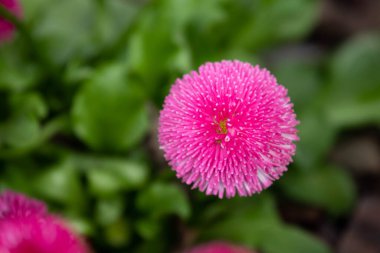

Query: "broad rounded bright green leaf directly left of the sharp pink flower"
<box><xmin>72</xmin><ymin>65</ymin><xmax>148</xmax><ymax>151</ymax></box>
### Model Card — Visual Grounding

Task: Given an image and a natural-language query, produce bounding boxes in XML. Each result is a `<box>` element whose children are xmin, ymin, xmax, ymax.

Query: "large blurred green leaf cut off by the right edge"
<box><xmin>325</xmin><ymin>33</ymin><xmax>380</xmax><ymax>127</ymax></box>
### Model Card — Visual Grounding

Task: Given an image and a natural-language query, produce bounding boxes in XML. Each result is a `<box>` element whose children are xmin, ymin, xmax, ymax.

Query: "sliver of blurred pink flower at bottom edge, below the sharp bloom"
<box><xmin>185</xmin><ymin>242</ymin><xmax>254</xmax><ymax>253</ymax></box>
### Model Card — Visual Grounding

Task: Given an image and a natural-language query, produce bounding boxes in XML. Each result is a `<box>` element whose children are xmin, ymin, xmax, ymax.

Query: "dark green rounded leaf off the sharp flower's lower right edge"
<box><xmin>280</xmin><ymin>167</ymin><xmax>356</xmax><ymax>215</ymax></box>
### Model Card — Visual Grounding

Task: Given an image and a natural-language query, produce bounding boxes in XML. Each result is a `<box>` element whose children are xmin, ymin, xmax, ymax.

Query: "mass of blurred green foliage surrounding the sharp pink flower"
<box><xmin>0</xmin><ymin>0</ymin><xmax>380</xmax><ymax>253</ymax></box>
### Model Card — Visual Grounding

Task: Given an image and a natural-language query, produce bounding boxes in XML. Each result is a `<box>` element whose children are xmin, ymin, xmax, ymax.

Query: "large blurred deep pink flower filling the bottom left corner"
<box><xmin>0</xmin><ymin>191</ymin><xmax>88</xmax><ymax>253</ymax></box>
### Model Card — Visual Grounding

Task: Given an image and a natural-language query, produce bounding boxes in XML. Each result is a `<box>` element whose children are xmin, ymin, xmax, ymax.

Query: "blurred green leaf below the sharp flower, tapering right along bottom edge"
<box><xmin>201</xmin><ymin>195</ymin><xmax>331</xmax><ymax>253</ymax></box>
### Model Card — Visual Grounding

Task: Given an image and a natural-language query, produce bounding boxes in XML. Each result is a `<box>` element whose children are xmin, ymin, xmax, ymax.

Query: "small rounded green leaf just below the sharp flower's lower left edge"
<box><xmin>137</xmin><ymin>182</ymin><xmax>191</xmax><ymax>219</ymax></box>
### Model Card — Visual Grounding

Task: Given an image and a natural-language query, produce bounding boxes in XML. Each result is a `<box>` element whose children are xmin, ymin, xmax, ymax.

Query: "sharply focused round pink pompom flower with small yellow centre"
<box><xmin>158</xmin><ymin>61</ymin><xmax>298</xmax><ymax>198</ymax></box>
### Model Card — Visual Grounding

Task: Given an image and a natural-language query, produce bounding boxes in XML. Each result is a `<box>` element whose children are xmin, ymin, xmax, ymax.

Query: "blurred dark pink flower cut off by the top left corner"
<box><xmin>0</xmin><ymin>0</ymin><xmax>21</xmax><ymax>42</ymax></box>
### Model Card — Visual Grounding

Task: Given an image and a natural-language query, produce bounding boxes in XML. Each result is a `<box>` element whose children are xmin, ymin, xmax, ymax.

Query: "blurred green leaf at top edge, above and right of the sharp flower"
<box><xmin>233</xmin><ymin>0</ymin><xmax>319</xmax><ymax>49</ymax></box>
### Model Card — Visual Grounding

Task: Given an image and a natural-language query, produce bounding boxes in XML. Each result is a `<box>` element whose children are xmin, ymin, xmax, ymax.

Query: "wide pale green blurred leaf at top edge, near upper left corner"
<box><xmin>31</xmin><ymin>0</ymin><xmax>136</xmax><ymax>64</ymax></box>
